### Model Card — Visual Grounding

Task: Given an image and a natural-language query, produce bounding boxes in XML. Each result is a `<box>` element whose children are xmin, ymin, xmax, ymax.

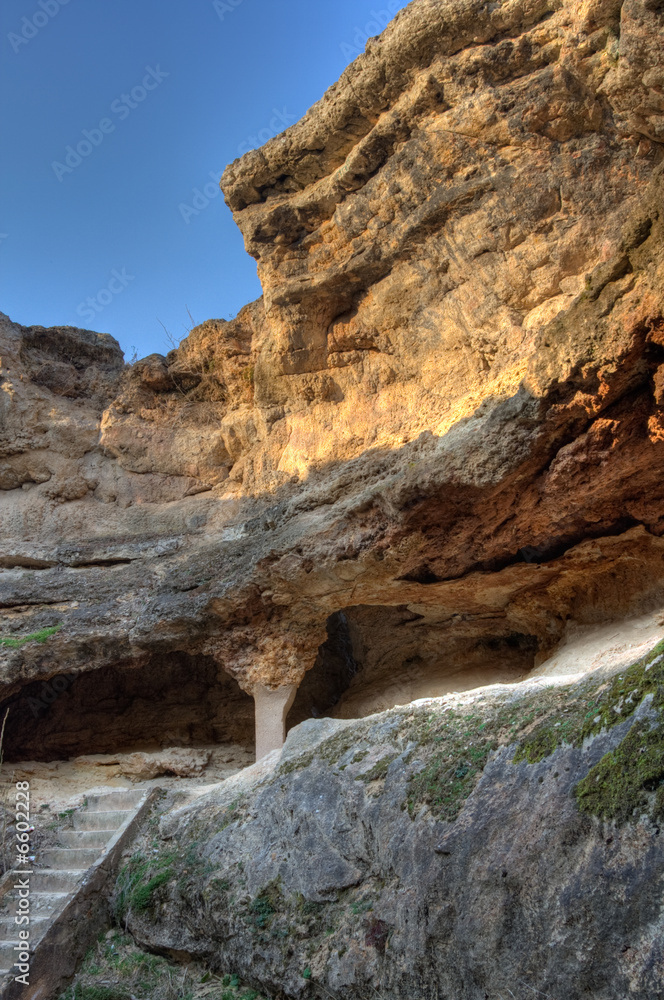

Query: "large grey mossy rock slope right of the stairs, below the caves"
<box><xmin>121</xmin><ymin>643</ymin><xmax>664</xmax><ymax>1000</ymax></box>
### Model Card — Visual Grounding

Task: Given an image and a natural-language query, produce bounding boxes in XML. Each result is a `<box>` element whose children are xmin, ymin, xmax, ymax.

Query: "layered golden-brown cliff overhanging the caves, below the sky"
<box><xmin>0</xmin><ymin>0</ymin><xmax>664</xmax><ymax>753</ymax></box>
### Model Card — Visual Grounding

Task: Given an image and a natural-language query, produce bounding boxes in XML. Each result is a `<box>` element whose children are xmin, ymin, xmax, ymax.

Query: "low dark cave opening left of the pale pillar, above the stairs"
<box><xmin>0</xmin><ymin>652</ymin><xmax>254</xmax><ymax>762</ymax></box>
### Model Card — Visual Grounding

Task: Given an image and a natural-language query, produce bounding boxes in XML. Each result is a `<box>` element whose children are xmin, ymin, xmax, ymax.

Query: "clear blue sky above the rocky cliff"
<box><xmin>0</xmin><ymin>0</ymin><xmax>406</xmax><ymax>357</ymax></box>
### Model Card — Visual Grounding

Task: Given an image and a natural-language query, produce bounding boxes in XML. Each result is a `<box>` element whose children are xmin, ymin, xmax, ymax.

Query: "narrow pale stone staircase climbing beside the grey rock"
<box><xmin>0</xmin><ymin>788</ymin><xmax>154</xmax><ymax>1000</ymax></box>
